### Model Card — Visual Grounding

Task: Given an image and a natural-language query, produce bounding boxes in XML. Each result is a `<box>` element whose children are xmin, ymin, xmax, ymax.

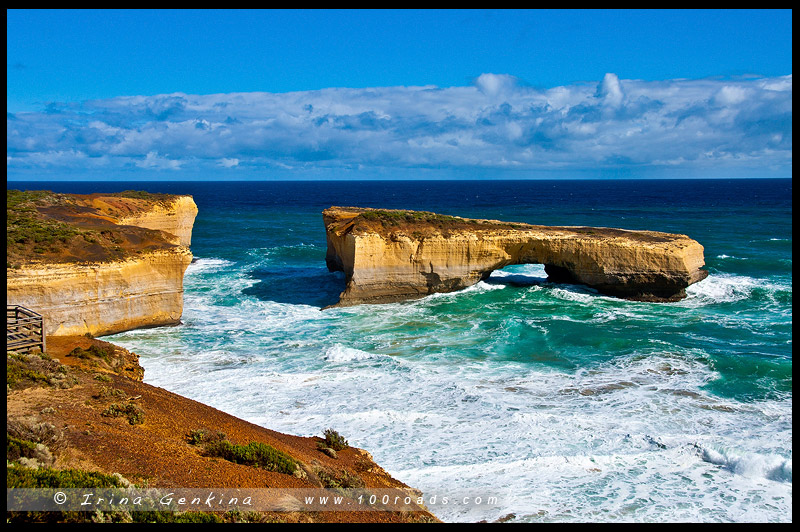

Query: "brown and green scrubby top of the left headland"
<box><xmin>6</xmin><ymin>190</ymin><xmax>191</xmax><ymax>268</ymax></box>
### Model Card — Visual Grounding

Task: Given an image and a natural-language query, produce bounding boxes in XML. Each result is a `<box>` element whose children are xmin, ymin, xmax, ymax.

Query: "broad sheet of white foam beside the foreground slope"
<box><xmin>126</xmin><ymin>330</ymin><xmax>791</xmax><ymax>521</ymax></box>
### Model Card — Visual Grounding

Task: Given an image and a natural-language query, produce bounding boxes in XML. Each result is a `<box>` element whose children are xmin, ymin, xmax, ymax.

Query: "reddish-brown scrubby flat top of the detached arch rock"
<box><xmin>322</xmin><ymin>206</ymin><xmax>689</xmax><ymax>244</ymax></box>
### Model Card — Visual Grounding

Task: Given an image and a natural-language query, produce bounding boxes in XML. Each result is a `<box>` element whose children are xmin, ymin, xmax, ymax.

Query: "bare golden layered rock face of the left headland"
<box><xmin>6</xmin><ymin>196</ymin><xmax>197</xmax><ymax>336</ymax></box>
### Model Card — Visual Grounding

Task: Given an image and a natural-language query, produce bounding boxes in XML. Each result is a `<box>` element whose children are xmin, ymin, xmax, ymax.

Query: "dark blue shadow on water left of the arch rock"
<box><xmin>242</xmin><ymin>266</ymin><xmax>346</xmax><ymax>308</ymax></box>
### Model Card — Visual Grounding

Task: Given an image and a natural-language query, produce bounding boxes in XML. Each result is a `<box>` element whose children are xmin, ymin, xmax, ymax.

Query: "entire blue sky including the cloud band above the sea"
<box><xmin>7</xmin><ymin>10</ymin><xmax>792</xmax><ymax>180</ymax></box>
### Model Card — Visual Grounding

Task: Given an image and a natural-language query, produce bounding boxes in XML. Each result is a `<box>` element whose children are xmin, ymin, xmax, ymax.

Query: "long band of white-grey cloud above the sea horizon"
<box><xmin>6</xmin><ymin>73</ymin><xmax>792</xmax><ymax>175</ymax></box>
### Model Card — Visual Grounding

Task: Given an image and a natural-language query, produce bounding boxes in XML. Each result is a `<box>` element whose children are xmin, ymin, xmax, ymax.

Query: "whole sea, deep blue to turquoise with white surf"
<box><xmin>8</xmin><ymin>179</ymin><xmax>792</xmax><ymax>522</ymax></box>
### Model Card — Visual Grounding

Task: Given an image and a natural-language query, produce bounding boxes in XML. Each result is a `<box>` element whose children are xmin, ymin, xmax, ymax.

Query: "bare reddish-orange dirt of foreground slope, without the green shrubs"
<box><xmin>7</xmin><ymin>337</ymin><xmax>444</xmax><ymax>522</ymax></box>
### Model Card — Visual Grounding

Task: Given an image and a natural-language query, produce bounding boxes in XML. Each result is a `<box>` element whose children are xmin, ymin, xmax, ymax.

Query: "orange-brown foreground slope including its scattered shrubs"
<box><xmin>6</xmin><ymin>336</ymin><xmax>437</xmax><ymax>522</ymax></box>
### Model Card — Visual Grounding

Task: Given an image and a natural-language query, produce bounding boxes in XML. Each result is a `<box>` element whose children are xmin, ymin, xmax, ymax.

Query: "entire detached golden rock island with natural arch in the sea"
<box><xmin>323</xmin><ymin>207</ymin><xmax>708</xmax><ymax>305</ymax></box>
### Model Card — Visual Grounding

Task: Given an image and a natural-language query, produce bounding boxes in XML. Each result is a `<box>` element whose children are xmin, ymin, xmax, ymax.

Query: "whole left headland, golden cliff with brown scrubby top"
<box><xmin>6</xmin><ymin>191</ymin><xmax>197</xmax><ymax>336</ymax></box>
